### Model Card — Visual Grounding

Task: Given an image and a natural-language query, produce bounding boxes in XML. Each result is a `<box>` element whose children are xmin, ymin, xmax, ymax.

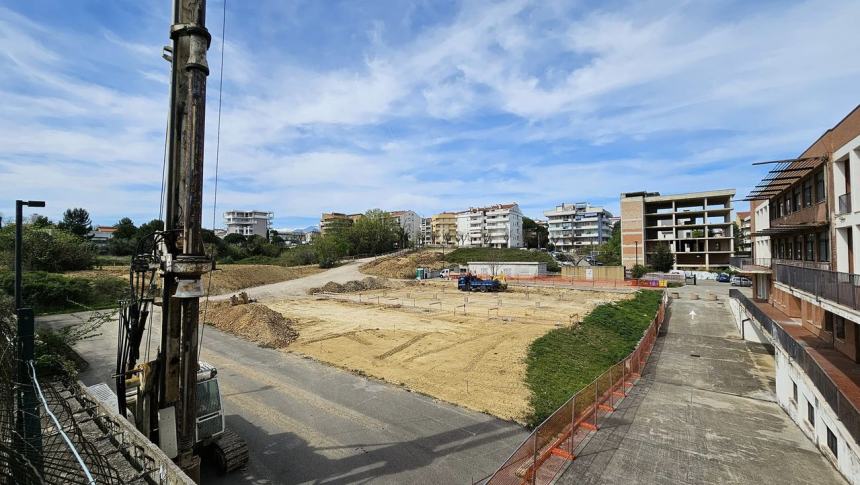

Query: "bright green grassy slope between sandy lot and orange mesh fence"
<box><xmin>526</xmin><ymin>290</ymin><xmax>663</xmax><ymax>426</ymax></box>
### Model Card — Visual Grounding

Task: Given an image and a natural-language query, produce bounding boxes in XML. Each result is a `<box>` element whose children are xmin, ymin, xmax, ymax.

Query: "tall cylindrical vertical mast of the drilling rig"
<box><xmin>158</xmin><ymin>0</ymin><xmax>212</xmax><ymax>476</ymax></box>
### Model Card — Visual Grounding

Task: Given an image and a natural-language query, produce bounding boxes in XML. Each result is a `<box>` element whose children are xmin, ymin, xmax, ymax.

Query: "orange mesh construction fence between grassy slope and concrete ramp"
<box><xmin>485</xmin><ymin>292</ymin><xmax>669</xmax><ymax>485</ymax></box>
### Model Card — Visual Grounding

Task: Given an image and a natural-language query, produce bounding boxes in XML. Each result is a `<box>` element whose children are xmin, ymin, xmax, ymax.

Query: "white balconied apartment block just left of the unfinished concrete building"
<box><xmin>543</xmin><ymin>202</ymin><xmax>612</xmax><ymax>252</ymax></box>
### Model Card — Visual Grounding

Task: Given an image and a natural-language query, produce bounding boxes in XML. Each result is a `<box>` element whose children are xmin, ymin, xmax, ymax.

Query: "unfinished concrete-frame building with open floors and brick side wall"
<box><xmin>621</xmin><ymin>189</ymin><xmax>735</xmax><ymax>271</ymax></box>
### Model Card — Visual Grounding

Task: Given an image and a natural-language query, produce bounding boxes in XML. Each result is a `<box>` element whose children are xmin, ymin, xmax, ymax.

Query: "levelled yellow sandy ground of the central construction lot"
<box><xmin>268</xmin><ymin>282</ymin><xmax>628</xmax><ymax>422</ymax></box>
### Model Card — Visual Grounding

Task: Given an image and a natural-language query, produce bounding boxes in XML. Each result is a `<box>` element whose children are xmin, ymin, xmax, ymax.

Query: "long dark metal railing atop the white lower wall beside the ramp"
<box><xmin>729</xmin><ymin>289</ymin><xmax>860</xmax><ymax>443</ymax></box>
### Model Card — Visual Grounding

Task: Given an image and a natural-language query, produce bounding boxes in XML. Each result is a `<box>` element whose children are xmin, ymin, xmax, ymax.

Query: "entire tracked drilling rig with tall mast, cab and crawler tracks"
<box><xmin>105</xmin><ymin>0</ymin><xmax>248</xmax><ymax>476</ymax></box>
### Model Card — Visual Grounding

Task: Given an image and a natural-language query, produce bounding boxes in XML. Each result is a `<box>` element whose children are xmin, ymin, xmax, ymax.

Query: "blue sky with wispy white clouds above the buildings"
<box><xmin>0</xmin><ymin>0</ymin><xmax>860</xmax><ymax>227</ymax></box>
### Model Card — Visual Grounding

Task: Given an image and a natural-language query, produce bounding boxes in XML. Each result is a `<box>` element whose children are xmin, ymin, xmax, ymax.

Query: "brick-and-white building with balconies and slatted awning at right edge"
<box><xmin>732</xmin><ymin>106</ymin><xmax>860</xmax><ymax>483</ymax></box>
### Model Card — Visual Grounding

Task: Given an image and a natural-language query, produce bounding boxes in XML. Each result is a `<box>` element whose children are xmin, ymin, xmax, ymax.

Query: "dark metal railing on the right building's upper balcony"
<box><xmin>774</xmin><ymin>264</ymin><xmax>860</xmax><ymax>310</ymax></box>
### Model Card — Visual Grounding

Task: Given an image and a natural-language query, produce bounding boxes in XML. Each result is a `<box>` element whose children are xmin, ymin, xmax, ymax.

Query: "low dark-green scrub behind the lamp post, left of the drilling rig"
<box><xmin>0</xmin><ymin>271</ymin><xmax>128</xmax><ymax>315</ymax></box>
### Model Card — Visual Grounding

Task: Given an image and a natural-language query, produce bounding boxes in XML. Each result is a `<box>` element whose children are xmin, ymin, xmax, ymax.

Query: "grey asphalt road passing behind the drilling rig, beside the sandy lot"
<box><xmin>37</xmin><ymin>265</ymin><xmax>527</xmax><ymax>484</ymax></box>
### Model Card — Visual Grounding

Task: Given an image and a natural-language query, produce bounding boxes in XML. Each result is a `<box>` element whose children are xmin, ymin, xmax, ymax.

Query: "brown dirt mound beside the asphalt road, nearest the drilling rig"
<box><xmin>200</xmin><ymin>301</ymin><xmax>299</xmax><ymax>348</ymax></box>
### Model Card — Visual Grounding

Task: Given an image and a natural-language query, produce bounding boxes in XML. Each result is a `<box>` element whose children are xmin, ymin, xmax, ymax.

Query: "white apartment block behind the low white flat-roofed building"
<box><xmin>456</xmin><ymin>203</ymin><xmax>525</xmax><ymax>248</ymax></box>
